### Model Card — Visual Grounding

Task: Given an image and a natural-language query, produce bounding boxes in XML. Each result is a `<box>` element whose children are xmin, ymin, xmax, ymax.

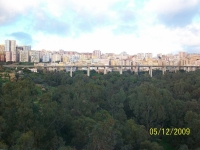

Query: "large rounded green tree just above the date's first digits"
<box><xmin>129</xmin><ymin>83</ymin><xmax>166</xmax><ymax>131</ymax></box>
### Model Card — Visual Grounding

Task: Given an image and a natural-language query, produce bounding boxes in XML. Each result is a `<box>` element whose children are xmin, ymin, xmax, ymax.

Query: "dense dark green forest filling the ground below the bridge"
<box><xmin>0</xmin><ymin>69</ymin><xmax>200</xmax><ymax>150</ymax></box>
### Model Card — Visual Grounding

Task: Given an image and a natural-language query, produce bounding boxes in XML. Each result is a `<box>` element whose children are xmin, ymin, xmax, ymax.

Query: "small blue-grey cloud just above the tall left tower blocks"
<box><xmin>10</xmin><ymin>32</ymin><xmax>33</xmax><ymax>45</ymax></box>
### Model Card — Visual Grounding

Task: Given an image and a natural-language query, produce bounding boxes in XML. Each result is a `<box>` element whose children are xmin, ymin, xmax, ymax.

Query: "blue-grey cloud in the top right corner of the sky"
<box><xmin>145</xmin><ymin>0</ymin><xmax>200</xmax><ymax>27</ymax></box>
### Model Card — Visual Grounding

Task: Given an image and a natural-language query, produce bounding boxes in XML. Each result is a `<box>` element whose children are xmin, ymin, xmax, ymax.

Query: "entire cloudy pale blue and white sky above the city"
<box><xmin>0</xmin><ymin>0</ymin><xmax>200</xmax><ymax>55</ymax></box>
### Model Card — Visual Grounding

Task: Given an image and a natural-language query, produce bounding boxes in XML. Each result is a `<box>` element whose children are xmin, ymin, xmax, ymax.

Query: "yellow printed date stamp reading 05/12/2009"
<box><xmin>149</xmin><ymin>128</ymin><xmax>190</xmax><ymax>136</ymax></box>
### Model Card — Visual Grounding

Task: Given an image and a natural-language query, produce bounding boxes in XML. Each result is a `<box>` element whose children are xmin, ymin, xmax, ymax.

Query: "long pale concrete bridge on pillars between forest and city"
<box><xmin>3</xmin><ymin>65</ymin><xmax>200</xmax><ymax>77</ymax></box>
